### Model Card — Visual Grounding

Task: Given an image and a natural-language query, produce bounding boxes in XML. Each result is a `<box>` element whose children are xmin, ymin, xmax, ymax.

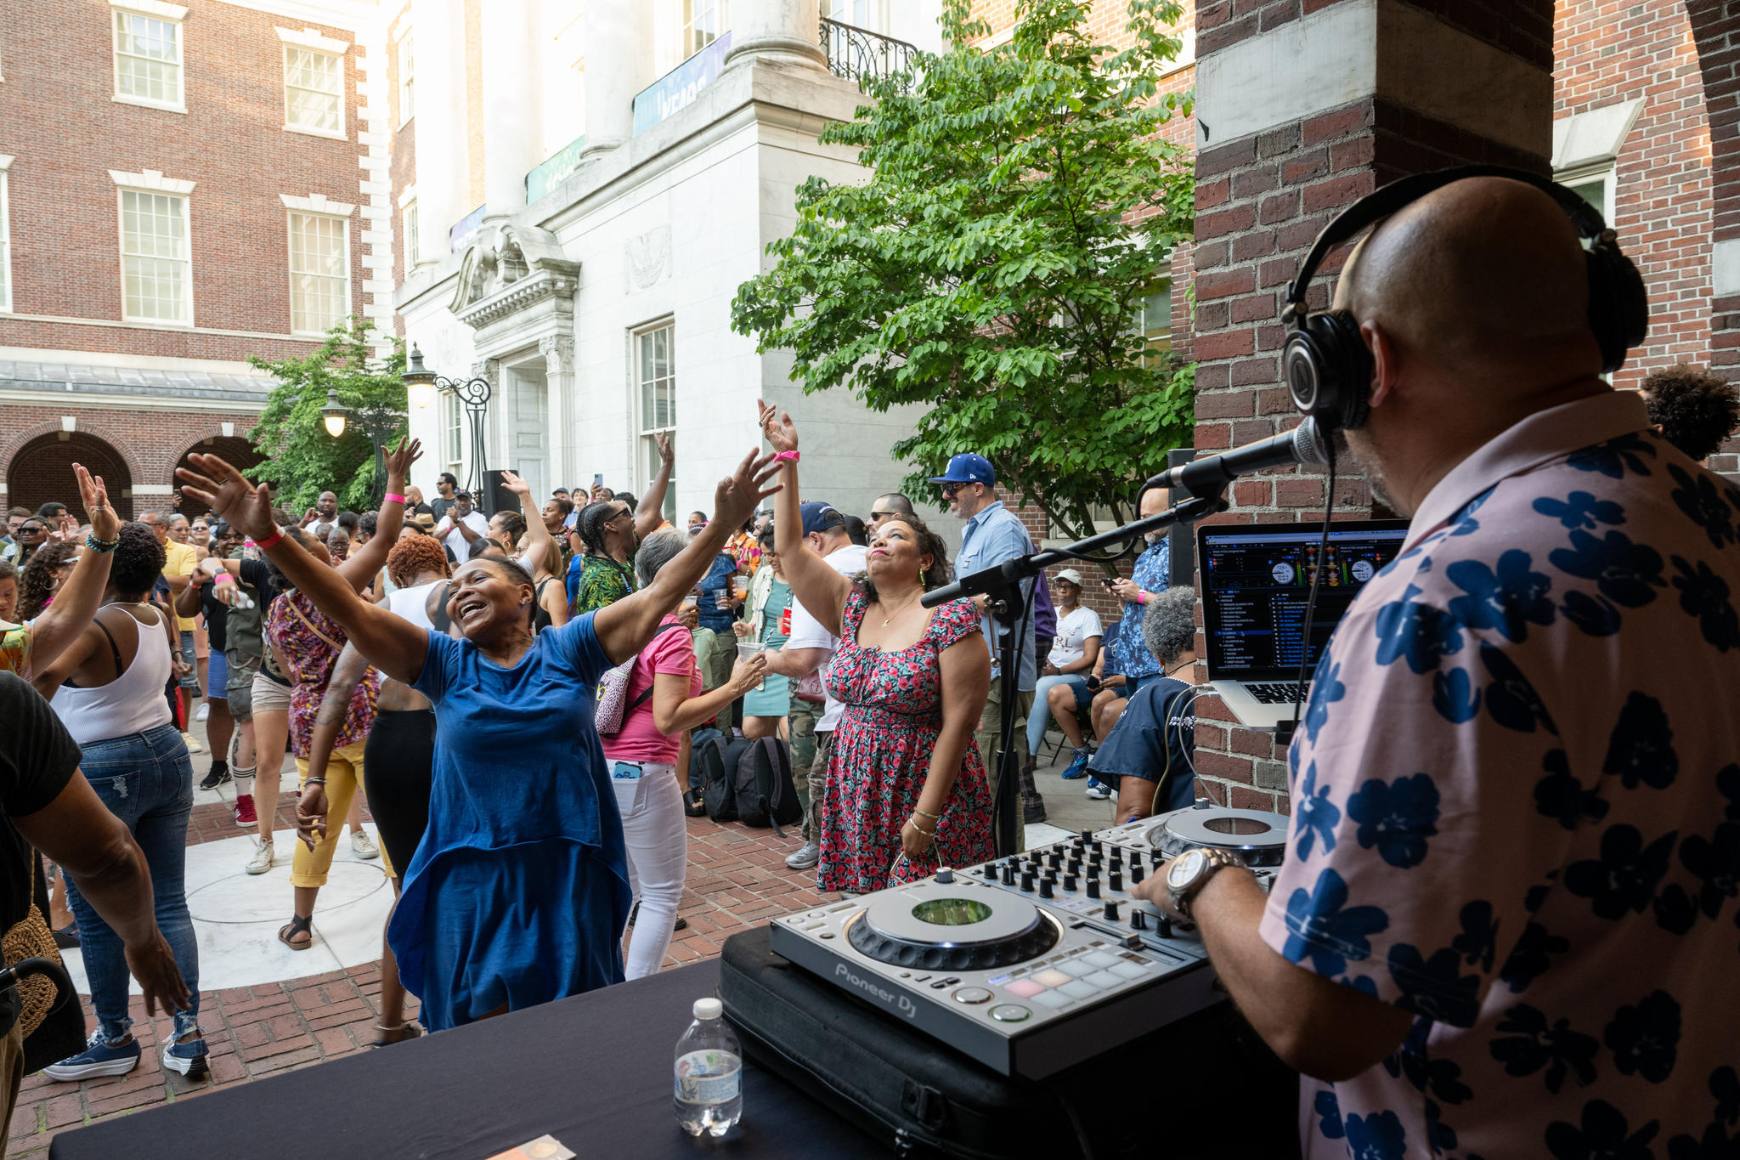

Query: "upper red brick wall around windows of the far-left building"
<box><xmin>0</xmin><ymin>0</ymin><xmax>364</xmax><ymax>360</ymax></box>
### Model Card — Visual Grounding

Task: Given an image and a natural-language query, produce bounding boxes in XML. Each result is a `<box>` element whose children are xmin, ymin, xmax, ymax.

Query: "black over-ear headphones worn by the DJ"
<box><xmin>1281</xmin><ymin>165</ymin><xmax>1650</xmax><ymax>435</ymax></box>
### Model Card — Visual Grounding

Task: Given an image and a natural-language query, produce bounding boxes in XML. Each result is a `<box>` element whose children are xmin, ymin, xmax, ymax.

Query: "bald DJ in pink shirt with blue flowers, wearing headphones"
<box><xmin>1138</xmin><ymin>167</ymin><xmax>1740</xmax><ymax>1157</ymax></box>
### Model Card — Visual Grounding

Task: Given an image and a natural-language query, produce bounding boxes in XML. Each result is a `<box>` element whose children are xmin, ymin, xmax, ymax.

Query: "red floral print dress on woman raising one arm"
<box><xmin>816</xmin><ymin>584</ymin><xmax>995</xmax><ymax>894</ymax></box>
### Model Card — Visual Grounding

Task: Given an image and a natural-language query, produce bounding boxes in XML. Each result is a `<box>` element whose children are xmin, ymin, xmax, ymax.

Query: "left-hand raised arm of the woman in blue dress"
<box><xmin>176</xmin><ymin>456</ymin><xmax>430</xmax><ymax>685</ymax></box>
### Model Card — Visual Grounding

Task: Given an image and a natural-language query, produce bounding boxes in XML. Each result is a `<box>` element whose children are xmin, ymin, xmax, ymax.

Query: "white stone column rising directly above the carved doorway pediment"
<box><xmin>482</xmin><ymin>0</ymin><xmax>543</xmax><ymax>221</ymax></box>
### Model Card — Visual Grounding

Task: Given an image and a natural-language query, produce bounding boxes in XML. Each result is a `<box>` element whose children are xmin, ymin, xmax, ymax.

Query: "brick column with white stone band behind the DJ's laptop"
<box><xmin>1194</xmin><ymin>0</ymin><xmax>1554</xmax><ymax>812</ymax></box>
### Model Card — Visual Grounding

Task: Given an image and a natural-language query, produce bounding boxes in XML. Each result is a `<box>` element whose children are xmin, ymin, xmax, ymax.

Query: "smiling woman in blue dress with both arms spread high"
<box><xmin>179</xmin><ymin>452</ymin><xmax>778</xmax><ymax>1031</ymax></box>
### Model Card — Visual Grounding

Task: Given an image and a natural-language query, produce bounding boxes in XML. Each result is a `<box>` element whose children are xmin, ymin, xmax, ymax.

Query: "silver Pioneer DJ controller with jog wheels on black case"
<box><xmin>771</xmin><ymin>803</ymin><xmax>1288</xmax><ymax>1078</ymax></box>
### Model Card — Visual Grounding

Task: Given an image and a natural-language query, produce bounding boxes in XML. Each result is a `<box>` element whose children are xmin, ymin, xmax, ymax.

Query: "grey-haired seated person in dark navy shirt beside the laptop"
<box><xmin>1088</xmin><ymin>586</ymin><xmax>1195</xmax><ymax>823</ymax></box>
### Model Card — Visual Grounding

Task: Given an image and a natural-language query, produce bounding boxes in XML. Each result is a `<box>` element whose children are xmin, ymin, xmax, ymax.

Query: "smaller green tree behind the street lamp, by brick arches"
<box><xmin>247</xmin><ymin>322</ymin><xmax>405</xmax><ymax>511</ymax></box>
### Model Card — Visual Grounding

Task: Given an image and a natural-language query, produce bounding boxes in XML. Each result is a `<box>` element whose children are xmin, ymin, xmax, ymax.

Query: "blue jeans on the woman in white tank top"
<box><xmin>66</xmin><ymin>723</ymin><xmax>200</xmax><ymax>1043</ymax></box>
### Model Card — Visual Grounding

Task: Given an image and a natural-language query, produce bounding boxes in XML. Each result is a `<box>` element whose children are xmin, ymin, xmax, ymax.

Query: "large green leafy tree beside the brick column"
<box><xmin>733</xmin><ymin>0</ymin><xmax>1195</xmax><ymax>536</ymax></box>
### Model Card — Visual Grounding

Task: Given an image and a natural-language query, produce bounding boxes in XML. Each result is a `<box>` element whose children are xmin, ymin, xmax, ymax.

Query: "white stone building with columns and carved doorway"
<box><xmin>393</xmin><ymin>0</ymin><xmax>941</xmax><ymax>513</ymax></box>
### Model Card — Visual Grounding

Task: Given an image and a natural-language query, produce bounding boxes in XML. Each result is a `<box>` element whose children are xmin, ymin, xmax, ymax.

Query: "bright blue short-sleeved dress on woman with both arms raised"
<box><xmin>386</xmin><ymin>614</ymin><xmax>630</xmax><ymax>1031</ymax></box>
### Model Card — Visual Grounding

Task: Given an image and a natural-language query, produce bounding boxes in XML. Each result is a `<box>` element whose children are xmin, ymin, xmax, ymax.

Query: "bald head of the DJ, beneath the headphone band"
<box><xmin>1336</xmin><ymin>177</ymin><xmax>1601</xmax><ymax>379</ymax></box>
